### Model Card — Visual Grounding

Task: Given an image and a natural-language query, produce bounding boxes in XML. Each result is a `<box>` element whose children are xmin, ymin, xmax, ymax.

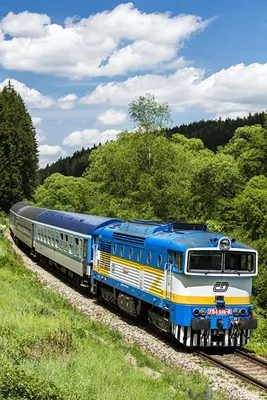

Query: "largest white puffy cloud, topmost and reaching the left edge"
<box><xmin>0</xmin><ymin>3</ymin><xmax>211</xmax><ymax>79</ymax></box>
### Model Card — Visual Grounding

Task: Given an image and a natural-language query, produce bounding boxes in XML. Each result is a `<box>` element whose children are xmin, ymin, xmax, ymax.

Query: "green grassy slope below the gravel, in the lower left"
<box><xmin>0</xmin><ymin>239</ymin><xmax>226</xmax><ymax>400</ymax></box>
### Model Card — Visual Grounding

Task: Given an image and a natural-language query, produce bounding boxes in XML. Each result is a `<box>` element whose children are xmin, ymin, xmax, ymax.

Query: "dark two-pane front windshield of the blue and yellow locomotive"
<box><xmin>188</xmin><ymin>250</ymin><xmax>256</xmax><ymax>275</ymax></box>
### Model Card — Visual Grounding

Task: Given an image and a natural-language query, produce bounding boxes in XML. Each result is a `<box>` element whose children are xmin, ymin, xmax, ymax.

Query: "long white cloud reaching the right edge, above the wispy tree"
<box><xmin>80</xmin><ymin>63</ymin><xmax>267</xmax><ymax>118</ymax></box>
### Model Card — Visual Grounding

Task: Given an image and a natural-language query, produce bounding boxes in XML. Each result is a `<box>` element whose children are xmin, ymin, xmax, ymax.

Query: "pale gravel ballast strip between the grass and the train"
<box><xmin>5</xmin><ymin>231</ymin><xmax>267</xmax><ymax>400</ymax></box>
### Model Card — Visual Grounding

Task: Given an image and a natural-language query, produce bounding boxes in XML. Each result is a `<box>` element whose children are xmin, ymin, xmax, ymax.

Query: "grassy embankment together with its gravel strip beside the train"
<box><xmin>0</xmin><ymin>231</ymin><xmax>263</xmax><ymax>400</ymax></box>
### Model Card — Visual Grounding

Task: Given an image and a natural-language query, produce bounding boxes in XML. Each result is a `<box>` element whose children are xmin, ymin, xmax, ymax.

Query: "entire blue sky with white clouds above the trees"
<box><xmin>0</xmin><ymin>0</ymin><xmax>267</xmax><ymax>166</ymax></box>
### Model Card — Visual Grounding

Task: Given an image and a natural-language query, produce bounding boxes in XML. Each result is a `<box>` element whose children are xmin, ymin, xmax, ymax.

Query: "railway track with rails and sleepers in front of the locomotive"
<box><xmin>195</xmin><ymin>349</ymin><xmax>267</xmax><ymax>392</ymax></box>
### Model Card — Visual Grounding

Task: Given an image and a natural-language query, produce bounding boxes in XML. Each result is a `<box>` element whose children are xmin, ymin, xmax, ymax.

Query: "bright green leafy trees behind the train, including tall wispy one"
<box><xmin>0</xmin><ymin>89</ymin><xmax>267</xmax><ymax>352</ymax></box>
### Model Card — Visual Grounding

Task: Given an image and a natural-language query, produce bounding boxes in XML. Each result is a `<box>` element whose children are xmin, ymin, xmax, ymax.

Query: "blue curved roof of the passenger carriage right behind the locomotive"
<box><xmin>37</xmin><ymin>210</ymin><xmax>122</xmax><ymax>235</ymax></box>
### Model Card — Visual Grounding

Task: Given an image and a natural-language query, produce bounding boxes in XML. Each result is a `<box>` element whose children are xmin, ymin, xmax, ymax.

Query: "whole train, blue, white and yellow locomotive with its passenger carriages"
<box><xmin>10</xmin><ymin>202</ymin><xmax>258</xmax><ymax>347</ymax></box>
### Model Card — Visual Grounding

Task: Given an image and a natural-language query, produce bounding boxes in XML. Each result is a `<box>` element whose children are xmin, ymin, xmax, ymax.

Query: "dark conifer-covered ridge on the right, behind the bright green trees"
<box><xmin>167</xmin><ymin>112</ymin><xmax>265</xmax><ymax>152</ymax></box>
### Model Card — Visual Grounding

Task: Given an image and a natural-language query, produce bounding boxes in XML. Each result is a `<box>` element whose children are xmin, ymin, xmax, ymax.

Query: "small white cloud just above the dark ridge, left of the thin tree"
<box><xmin>63</xmin><ymin>129</ymin><xmax>120</xmax><ymax>147</ymax></box>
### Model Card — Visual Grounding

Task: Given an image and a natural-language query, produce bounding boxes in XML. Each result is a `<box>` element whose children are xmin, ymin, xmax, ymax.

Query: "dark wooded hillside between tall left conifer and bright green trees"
<box><xmin>39</xmin><ymin>143</ymin><xmax>101</xmax><ymax>184</ymax></box>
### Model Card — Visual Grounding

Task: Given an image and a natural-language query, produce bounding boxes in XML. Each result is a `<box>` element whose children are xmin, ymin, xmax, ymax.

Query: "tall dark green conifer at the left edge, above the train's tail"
<box><xmin>0</xmin><ymin>82</ymin><xmax>38</xmax><ymax>212</ymax></box>
